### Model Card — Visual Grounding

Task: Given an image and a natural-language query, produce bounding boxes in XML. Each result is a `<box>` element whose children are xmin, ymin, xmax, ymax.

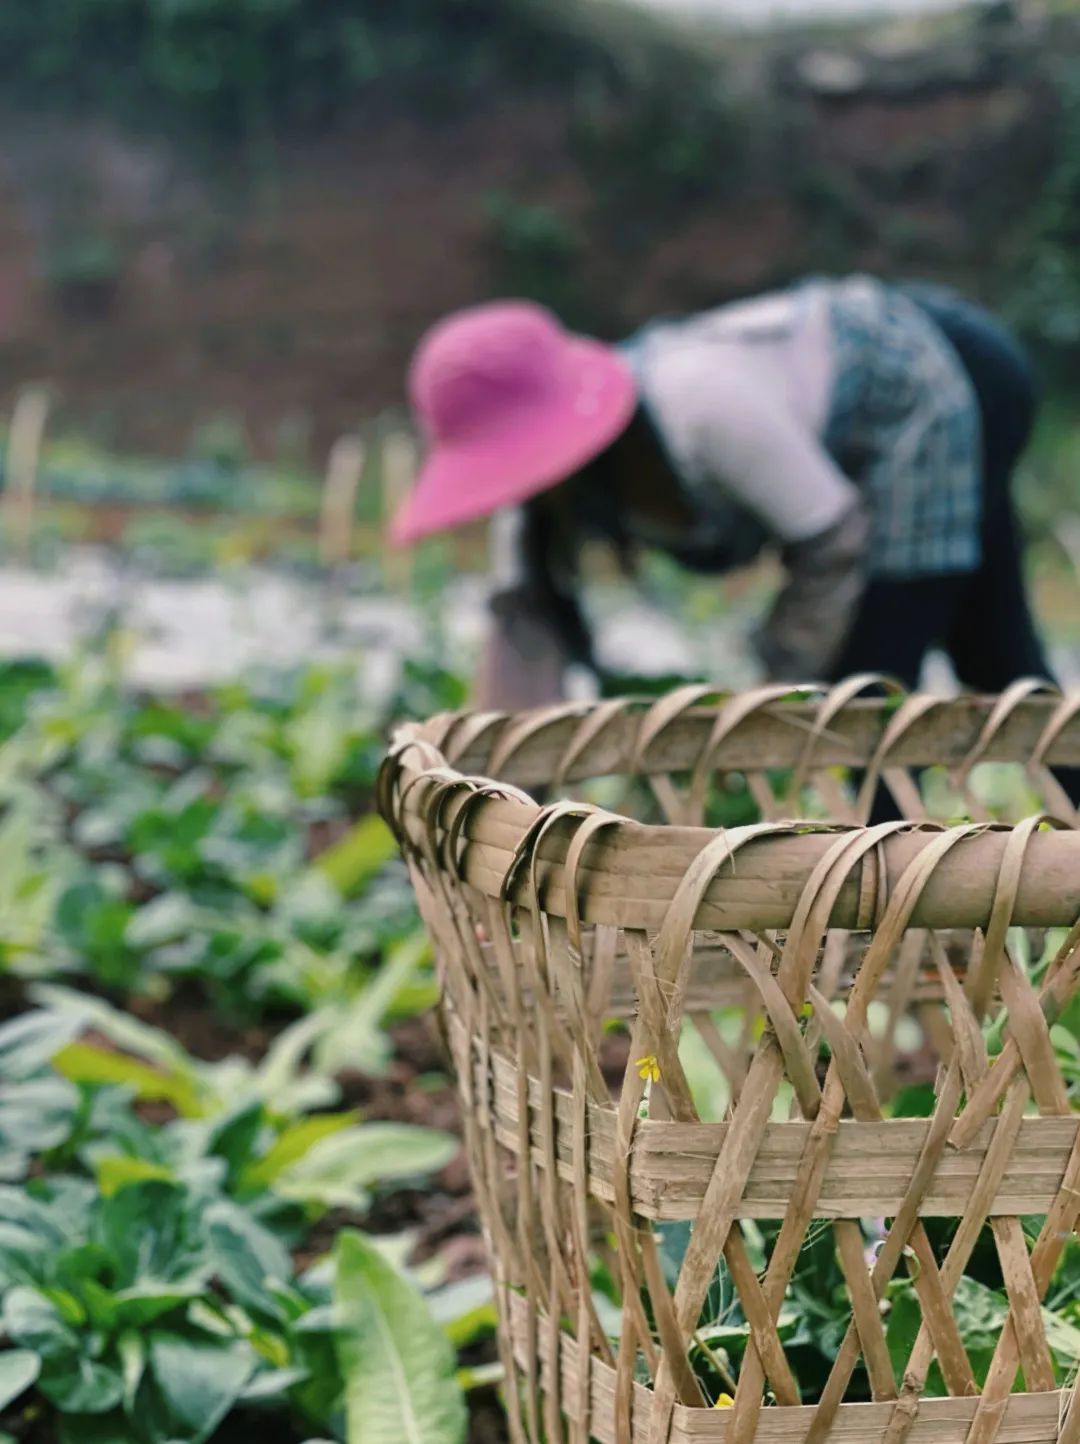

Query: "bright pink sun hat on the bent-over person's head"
<box><xmin>391</xmin><ymin>300</ymin><xmax>637</xmax><ymax>544</ymax></box>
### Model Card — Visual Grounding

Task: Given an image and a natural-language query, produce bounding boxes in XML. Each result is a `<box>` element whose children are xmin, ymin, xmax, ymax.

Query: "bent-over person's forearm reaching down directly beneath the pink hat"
<box><xmin>474</xmin><ymin>507</ymin><xmax>592</xmax><ymax>712</ymax></box>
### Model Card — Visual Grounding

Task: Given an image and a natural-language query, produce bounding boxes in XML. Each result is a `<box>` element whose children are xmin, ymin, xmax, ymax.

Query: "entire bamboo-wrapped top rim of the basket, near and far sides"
<box><xmin>380</xmin><ymin>687</ymin><xmax>1080</xmax><ymax>930</ymax></box>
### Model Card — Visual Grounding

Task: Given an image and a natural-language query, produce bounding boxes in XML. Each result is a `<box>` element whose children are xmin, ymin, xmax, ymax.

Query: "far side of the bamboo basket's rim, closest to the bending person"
<box><xmin>397</xmin><ymin>677</ymin><xmax>1080</xmax><ymax>788</ymax></box>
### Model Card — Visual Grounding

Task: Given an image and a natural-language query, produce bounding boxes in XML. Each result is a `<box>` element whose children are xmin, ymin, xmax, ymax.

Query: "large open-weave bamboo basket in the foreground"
<box><xmin>380</xmin><ymin>677</ymin><xmax>1080</xmax><ymax>1444</ymax></box>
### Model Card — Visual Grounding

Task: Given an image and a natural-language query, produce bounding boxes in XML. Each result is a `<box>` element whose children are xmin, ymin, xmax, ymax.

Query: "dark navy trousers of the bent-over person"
<box><xmin>836</xmin><ymin>287</ymin><xmax>1080</xmax><ymax>820</ymax></box>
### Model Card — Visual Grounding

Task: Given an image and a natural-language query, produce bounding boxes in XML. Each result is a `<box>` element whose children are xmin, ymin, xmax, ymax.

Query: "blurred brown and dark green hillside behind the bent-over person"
<box><xmin>0</xmin><ymin>0</ymin><xmax>1080</xmax><ymax>455</ymax></box>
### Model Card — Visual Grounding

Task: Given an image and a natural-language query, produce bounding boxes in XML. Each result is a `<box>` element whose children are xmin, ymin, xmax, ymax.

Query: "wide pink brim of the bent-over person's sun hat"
<box><xmin>390</xmin><ymin>338</ymin><xmax>637</xmax><ymax>546</ymax></box>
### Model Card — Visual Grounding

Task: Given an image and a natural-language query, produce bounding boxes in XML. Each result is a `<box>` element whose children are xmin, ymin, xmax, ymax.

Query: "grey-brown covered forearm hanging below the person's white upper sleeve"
<box><xmin>752</xmin><ymin>503</ymin><xmax>871</xmax><ymax>682</ymax></box>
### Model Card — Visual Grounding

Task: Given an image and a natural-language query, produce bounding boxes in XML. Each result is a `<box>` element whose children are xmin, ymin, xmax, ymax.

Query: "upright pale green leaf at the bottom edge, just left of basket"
<box><xmin>334</xmin><ymin>1230</ymin><xmax>466</xmax><ymax>1444</ymax></box>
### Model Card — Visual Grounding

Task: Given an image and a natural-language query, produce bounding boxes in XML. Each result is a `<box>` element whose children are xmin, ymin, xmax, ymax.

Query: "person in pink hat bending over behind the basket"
<box><xmin>394</xmin><ymin>276</ymin><xmax>1047</xmax><ymax>709</ymax></box>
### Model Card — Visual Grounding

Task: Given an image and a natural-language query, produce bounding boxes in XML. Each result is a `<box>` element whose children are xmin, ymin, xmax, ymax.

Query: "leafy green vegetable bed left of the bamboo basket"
<box><xmin>0</xmin><ymin>650</ymin><xmax>502</xmax><ymax>1444</ymax></box>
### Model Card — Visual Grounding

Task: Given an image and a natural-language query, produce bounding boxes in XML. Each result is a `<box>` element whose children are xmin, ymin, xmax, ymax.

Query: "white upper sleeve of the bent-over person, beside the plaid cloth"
<box><xmin>656</xmin><ymin>349</ymin><xmax>859</xmax><ymax>543</ymax></box>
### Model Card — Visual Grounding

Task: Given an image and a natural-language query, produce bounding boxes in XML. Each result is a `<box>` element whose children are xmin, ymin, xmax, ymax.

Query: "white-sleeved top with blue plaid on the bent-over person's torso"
<box><xmin>612</xmin><ymin>276</ymin><xmax>982</xmax><ymax>579</ymax></box>
